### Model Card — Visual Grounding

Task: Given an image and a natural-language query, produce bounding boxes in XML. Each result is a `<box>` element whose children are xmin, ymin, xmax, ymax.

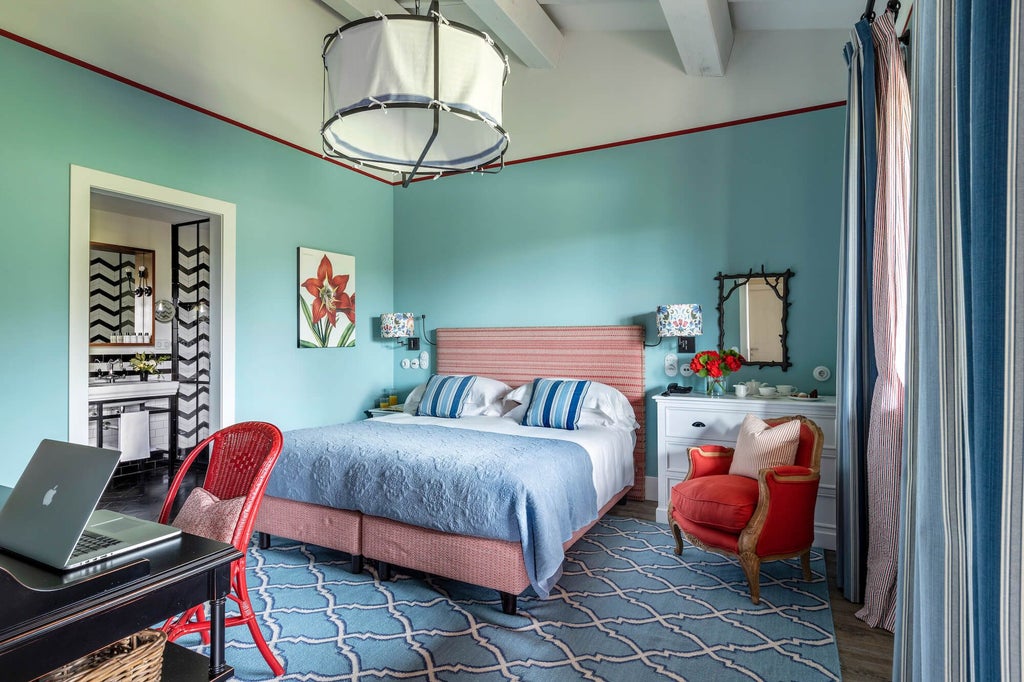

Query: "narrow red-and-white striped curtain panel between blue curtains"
<box><xmin>857</xmin><ymin>10</ymin><xmax>910</xmax><ymax>631</ymax></box>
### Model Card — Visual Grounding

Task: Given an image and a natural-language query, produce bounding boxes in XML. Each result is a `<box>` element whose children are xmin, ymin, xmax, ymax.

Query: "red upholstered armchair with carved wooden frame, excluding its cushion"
<box><xmin>669</xmin><ymin>417</ymin><xmax>823</xmax><ymax>604</ymax></box>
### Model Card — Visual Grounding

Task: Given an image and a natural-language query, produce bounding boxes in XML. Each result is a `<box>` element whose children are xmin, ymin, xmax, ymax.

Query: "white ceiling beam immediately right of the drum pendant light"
<box><xmin>464</xmin><ymin>0</ymin><xmax>564</xmax><ymax>69</ymax></box>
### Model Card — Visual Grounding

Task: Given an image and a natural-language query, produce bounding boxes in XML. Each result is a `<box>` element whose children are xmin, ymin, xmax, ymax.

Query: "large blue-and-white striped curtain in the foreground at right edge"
<box><xmin>893</xmin><ymin>0</ymin><xmax>1024</xmax><ymax>681</ymax></box>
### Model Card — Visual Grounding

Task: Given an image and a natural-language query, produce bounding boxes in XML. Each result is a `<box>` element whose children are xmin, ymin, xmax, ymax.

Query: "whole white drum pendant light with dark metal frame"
<box><xmin>321</xmin><ymin>0</ymin><xmax>509</xmax><ymax>186</ymax></box>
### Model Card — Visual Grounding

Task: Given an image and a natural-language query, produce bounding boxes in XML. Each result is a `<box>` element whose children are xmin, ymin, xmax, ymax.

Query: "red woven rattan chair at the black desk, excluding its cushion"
<box><xmin>160</xmin><ymin>422</ymin><xmax>285</xmax><ymax>676</ymax></box>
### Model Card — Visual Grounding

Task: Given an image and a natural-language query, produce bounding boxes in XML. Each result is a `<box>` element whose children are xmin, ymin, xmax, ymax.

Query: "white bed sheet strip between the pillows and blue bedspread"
<box><xmin>374</xmin><ymin>413</ymin><xmax>636</xmax><ymax>509</ymax></box>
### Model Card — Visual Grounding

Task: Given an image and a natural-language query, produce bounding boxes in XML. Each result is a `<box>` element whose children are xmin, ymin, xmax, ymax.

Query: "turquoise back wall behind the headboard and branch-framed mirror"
<box><xmin>394</xmin><ymin>108</ymin><xmax>845</xmax><ymax>475</ymax></box>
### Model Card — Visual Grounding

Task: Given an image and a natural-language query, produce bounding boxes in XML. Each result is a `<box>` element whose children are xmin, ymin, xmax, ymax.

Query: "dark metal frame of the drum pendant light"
<box><xmin>321</xmin><ymin>0</ymin><xmax>509</xmax><ymax>187</ymax></box>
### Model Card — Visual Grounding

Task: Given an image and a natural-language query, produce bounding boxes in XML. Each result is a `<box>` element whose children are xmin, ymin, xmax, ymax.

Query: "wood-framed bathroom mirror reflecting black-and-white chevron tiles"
<box><xmin>89</xmin><ymin>242</ymin><xmax>156</xmax><ymax>346</ymax></box>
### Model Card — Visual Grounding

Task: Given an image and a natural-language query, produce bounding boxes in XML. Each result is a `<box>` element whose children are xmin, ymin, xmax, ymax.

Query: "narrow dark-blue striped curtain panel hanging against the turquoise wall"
<box><xmin>836</xmin><ymin>19</ymin><xmax>878</xmax><ymax>602</ymax></box>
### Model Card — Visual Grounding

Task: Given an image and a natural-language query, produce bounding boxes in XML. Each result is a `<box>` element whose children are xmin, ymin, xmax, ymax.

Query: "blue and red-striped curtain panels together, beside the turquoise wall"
<box><xmin>837</xmin><ymin>11</ymin><xmax>910</xmax><ymax>630</ymax></box>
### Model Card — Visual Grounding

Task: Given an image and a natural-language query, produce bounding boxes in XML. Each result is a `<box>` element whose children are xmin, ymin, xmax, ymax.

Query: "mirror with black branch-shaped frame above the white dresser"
<box><xmin>715</xmin><ymin>265</ymin><xmax>795</xmax><ymax>372</ymax></box>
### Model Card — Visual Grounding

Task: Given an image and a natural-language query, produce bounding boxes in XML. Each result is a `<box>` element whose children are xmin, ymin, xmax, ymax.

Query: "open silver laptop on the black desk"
<box><xmin>0</xmin><ymin>440</ymin><xmax>181</xmax><ymax>570</ymax></box>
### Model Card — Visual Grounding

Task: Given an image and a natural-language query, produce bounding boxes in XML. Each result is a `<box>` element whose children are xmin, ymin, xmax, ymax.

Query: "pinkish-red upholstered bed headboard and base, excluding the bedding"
<box><xmin>256</xmin><ymin>327</ymin><xmax>644</xmax><ymax>613</ymax></box>
